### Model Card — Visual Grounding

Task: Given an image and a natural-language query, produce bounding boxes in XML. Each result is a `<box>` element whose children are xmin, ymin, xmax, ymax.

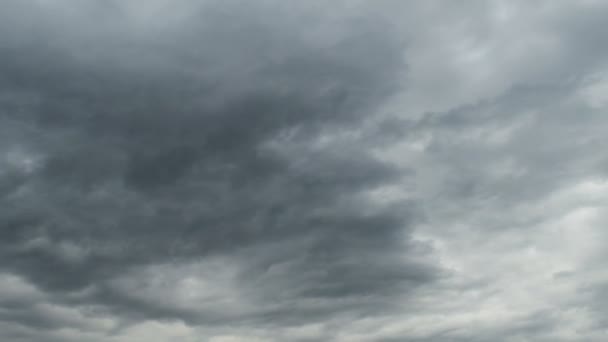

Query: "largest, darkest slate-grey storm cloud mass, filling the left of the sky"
<box><xmin>0</xmin><ymin>2</ymin><xmax>437</xmax><ymax>336</ymax></box>
